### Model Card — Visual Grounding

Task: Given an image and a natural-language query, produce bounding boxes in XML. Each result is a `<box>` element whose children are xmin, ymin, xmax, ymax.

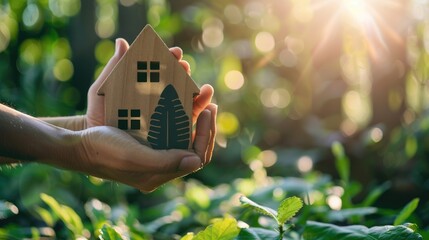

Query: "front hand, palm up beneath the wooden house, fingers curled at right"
<box><xmin>75</xmin><ymin>102</ymin><xmax>216</xmax><ymax>192</ymax></box>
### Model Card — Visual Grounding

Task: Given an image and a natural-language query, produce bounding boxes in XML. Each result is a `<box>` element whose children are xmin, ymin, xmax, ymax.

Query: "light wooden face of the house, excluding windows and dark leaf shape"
<box><xmin>97</xmin><ymin>25</ymin><xmax>199</xmax><ymax>149</ymax></box>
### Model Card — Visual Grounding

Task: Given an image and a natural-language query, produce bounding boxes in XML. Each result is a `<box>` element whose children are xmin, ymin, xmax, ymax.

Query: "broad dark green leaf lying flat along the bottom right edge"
<box><xmin>304</xmin><ymin>221</ymin><xmax>423</xmax><ymax>240</ymax></box>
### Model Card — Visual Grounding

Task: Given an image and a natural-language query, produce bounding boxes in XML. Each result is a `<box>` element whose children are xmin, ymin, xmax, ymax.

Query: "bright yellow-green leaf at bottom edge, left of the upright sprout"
<box><xmin>193</xmin><ymin>217</ymin><xmax>240</xmax><ymax>240</ymax></box>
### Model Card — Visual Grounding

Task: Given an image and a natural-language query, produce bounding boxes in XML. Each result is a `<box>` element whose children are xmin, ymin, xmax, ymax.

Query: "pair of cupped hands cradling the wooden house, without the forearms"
<box><xmin>77</xmin><ymin>39</ymin><xmax>217</xmax><ymax>192</ymax></box>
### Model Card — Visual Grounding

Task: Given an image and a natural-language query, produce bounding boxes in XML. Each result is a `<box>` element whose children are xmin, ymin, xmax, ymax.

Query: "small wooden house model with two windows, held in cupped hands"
<box><xmin>97</xmin><ymin>25</ymin><xmax>199</xmax><ymax>149</ymax></box>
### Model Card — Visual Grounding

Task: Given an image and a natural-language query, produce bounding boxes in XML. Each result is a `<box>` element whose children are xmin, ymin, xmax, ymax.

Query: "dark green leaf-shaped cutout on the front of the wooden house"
<box><xmin>147</xmin><ymin>84</ymin><xmax>190</xmax><ymax>149</ymax></box>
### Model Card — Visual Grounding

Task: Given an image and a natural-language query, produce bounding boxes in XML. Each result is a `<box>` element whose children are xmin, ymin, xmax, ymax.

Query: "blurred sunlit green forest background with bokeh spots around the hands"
<box><xmin>0</xmin><ymin>0</ymin><xmax>429</xmax><ymax>239</ymax></box>
